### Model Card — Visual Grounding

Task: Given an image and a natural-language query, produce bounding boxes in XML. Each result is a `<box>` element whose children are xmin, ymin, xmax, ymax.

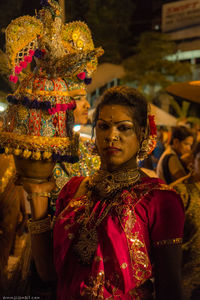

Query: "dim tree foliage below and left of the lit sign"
<box><xmin>124</xmin><ymin>32</ymin><xmax>191</xmax><ymax>96</ymax></box>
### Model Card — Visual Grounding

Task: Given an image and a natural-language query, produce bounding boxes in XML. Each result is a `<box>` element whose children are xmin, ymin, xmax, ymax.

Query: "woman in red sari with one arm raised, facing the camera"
<box><xmin>23</xmin><ymin>86</ymin><xmax>184</xmax><ymax>300</ymax></box>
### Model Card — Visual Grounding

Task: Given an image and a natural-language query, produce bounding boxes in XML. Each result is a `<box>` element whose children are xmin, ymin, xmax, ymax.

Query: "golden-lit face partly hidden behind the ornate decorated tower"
<box><xmin>73</xmin><ymin>91</ymin><xmax>90</xmax><ymax>125</ymax></box>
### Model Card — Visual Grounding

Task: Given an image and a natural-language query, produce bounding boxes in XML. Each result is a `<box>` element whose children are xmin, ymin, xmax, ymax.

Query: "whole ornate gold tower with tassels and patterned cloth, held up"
<box><xmin>0</xmin><ymin>0</ymin><xmax>103</xmax><ymax>162</ymax></box>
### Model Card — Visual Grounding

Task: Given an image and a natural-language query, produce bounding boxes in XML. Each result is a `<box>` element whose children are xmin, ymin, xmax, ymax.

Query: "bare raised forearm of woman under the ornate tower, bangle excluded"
<box><xmin>23</xmin><ymin>182</ymin><xmax>56</xmax><ymax>281</ymax></box>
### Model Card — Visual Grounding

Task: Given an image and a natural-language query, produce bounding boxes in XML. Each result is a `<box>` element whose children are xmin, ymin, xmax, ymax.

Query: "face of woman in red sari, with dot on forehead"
<box><xmin>96</xmin><ymin>105</ymin><xmax>139</xmax><ymax>171</ymax></box>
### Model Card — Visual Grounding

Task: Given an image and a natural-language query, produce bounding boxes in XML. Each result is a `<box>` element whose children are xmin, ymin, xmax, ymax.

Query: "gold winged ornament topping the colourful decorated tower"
<box><xmin>6</xmin><ymin>0</ymin><xmax>103</xmax><ymax>77</ymax></box>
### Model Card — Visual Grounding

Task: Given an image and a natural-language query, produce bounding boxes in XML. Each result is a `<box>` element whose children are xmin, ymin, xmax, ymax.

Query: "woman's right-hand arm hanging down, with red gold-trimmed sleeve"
<box><xmin>149</xmin><ymin>187</ymin><xmax>184</xmax><ymax>300</ymax></box>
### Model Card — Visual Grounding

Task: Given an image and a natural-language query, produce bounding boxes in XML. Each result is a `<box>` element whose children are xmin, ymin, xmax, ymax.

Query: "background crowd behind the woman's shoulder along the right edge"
<box><xmin>140</xmin><ymin>126</ymin><xmax>200</xmax><ymax>300</ymax></box>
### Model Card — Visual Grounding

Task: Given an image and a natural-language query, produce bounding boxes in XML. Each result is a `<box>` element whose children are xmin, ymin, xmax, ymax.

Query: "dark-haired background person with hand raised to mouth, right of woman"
<box><xmin>156</xmin><ymin>126</ymin><xmax>194</xmax><ymax>184</ymax></box>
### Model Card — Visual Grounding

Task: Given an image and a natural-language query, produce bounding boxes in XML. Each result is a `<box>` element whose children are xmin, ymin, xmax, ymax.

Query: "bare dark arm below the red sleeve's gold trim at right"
<box><xmin>154</xmin><ymin>245</ymin><xmax>183</xmax><ymax>300</ymax></box>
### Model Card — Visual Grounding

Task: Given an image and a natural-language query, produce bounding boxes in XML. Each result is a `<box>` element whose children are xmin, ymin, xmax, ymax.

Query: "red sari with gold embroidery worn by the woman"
<box><xmin>54</xmin><ymin>177</ymin><xmax>184</xmax><ymax>300</ymax></box>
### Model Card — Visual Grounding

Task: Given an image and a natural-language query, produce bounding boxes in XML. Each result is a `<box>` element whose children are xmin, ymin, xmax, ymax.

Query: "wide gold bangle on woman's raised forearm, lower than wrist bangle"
<box><xmin>28</xmin><ymin>215</ymin><xmax>51</xmax><ymax>234</ymax></box>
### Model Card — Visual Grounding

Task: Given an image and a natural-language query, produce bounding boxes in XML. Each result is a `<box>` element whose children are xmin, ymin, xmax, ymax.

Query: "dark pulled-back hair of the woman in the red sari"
<box><xmin>92</xmin><ymin>86</ymin><xmax>149</xmax><ymax>140</ymax></box>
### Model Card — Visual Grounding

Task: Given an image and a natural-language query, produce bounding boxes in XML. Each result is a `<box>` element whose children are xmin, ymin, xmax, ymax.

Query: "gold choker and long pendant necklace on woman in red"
<box><xmin>74</xmin><ymin>168</ymin><xmax>140</xmax><ymax>265</ymax></box>
